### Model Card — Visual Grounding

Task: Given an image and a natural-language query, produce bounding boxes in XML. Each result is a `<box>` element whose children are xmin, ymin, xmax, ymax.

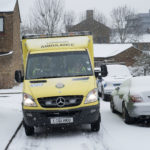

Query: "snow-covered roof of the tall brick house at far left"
<box><xmin>0</xmin><ymin>0</ymin><xmax>16</xmax><ymax>12</ymax></box>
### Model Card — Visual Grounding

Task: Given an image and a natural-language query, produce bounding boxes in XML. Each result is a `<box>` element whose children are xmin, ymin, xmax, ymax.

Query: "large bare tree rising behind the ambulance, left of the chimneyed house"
<box><xmin>30</xmin><ymin>0</ymin><xmax>64</xmax><ymax>34</ymax></box>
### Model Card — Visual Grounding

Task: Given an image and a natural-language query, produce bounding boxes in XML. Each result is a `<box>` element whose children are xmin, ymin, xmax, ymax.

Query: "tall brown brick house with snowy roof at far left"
<box><xmin>0</xmin><ymin>0</ymin><xmax>22</xmax><ymax>88</ymax></box>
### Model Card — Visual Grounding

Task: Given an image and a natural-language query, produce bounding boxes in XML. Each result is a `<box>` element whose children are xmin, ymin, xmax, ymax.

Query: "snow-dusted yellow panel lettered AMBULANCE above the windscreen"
<box><xmin>26</xmin><ymin>37</ymin><xmax>89</xmax><ymax>50</ymax></box>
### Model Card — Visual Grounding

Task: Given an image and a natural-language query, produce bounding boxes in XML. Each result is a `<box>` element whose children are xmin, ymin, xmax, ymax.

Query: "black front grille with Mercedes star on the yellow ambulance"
<box><xmin>37</xmin><ymin>96</ymin><xmax>83</xmax><ymax>108</ymax></box>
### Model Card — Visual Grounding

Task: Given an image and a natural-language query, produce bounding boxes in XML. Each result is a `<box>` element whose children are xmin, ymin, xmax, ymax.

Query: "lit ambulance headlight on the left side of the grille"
<box><xmin>23</xmin><ymin>93</ymin><xmax>37</xmax><ymax>107</ymax></box>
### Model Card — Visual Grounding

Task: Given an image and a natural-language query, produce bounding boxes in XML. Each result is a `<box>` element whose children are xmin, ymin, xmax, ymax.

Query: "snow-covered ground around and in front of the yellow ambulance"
<box><xmin>0</xmin><ymin>86</ymin><xmax>150</xmax><ymax>150</ymax></box>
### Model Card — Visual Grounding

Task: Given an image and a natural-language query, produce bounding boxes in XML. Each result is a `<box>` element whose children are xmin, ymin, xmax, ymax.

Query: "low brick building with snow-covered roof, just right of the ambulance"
<box><xmin>94</xmin><ymin>44</ymin><xmax>142</xmax><ymax>66</ymax></box>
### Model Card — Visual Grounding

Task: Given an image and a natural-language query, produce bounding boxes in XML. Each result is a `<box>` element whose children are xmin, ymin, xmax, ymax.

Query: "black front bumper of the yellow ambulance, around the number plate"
<box><xmin>23</xmin><ymin>105</ymin><xmax>100</xmax><ymax>127</ymax></box>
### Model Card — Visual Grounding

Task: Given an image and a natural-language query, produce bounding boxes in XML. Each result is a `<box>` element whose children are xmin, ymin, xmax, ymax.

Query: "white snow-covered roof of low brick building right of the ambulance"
<box><xmin>94</xmin><ymin>44</ymin><xmax>132</xmax><ymax>58</ymax></box>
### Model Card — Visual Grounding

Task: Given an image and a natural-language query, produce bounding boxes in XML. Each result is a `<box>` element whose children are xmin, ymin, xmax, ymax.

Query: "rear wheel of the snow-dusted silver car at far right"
<box><xmin>122</xmin><ymin>104</ymin><xmax>133</xmax><ymax>124</ymax></box>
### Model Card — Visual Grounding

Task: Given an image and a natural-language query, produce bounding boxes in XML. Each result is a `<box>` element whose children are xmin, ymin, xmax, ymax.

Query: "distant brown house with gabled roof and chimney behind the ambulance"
<box><xmin>67</xmin><ymin>10</ymin><xmax>110</xmax><ymax>43</ymax></box>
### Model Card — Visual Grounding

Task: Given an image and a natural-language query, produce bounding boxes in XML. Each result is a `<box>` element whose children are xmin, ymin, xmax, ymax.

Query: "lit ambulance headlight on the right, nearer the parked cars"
<box><xmin>84</xmin><ymin>88</ymin><xmax>98</xmax><ymax>104</ymax></box>
